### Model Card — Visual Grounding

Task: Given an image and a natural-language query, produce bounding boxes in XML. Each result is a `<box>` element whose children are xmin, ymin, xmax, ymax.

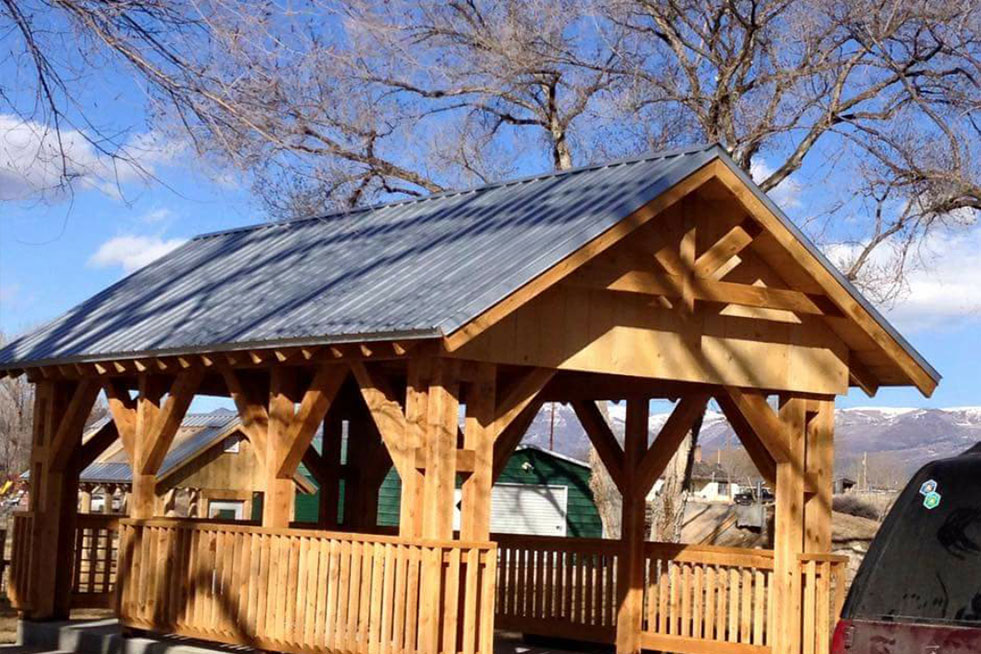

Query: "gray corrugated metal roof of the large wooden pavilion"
<box><xmin>0</xmin><ymin>145</ymin><xmax>939</xmax><ymax>379</ymax></box>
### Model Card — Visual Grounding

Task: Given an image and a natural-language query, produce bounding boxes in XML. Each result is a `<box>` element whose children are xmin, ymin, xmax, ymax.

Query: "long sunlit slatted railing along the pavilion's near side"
<box><xmin>118</xmin><ymin>519</ymin><xmax>497</xmax><ymax>654</ymax></box>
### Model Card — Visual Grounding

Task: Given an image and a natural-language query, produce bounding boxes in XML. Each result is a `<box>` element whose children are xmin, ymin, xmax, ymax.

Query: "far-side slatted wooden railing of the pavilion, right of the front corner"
<box><xmin>494</xmin><ymin>535</ymin><xmax>846</xmax><ymax>654</ymax></box>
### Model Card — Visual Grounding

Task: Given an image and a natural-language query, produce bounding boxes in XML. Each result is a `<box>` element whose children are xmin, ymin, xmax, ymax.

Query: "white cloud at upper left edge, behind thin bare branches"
<box><xmin>0</xmin><ymin>114</ymin><xmax>184</xmax><ymax>201</ymax></box>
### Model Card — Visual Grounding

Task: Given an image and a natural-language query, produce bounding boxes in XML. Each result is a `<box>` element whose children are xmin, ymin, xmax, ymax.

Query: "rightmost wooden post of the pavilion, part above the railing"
<box><xmin>804</xmin><ymin>398</ymin><xmax>835</xmax><ymax>554</ymax></box>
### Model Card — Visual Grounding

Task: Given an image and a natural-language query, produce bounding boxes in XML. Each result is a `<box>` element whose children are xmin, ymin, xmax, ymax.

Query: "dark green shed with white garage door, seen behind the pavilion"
<box><xmin>295</xmin><ymin>445</ymin><xmax>603</xmax><ymax>538</ymax></box>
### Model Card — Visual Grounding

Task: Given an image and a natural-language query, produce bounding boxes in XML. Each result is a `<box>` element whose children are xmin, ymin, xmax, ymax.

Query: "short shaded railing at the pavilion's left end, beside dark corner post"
<box><xmin>71</xmin><ymin>513</ymin><xmax>120</xmax><ymax>608</ymax></box>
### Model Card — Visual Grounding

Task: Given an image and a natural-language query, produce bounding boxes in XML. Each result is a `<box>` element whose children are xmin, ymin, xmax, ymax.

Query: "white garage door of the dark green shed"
<box><xmin>453</xmin><ymin>484</ymin><xmax>569</xmax><ymax>536</ymax></box>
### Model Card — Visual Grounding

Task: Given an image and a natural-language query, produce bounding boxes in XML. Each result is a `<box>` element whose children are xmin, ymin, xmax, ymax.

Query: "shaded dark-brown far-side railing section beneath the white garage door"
<box><xmin>493</xmin><ymin>534</ymin><xmax>620</xmax><ymax>643</ymax></box>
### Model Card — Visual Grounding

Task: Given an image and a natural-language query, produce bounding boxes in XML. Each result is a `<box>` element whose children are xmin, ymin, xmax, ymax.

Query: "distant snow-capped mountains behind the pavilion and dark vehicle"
<box><xmin>525</xmin><ymin>404</ymin><xmax>981</xmax><ymax>484</ymax></box>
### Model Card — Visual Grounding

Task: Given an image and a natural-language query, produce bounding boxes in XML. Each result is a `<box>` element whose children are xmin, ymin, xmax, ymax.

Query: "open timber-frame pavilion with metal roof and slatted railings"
<box><xmin>0</xmin><ymin>146</ymin><xmax>939</xmax><ymax>654</ymax></box>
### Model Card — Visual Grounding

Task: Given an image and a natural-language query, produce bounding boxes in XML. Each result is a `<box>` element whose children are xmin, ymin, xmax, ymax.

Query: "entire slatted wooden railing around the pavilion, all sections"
<box><xmin>10</xmin><ymin>513</ymin><xmax>847</xmax><ymax>654</ymax></box>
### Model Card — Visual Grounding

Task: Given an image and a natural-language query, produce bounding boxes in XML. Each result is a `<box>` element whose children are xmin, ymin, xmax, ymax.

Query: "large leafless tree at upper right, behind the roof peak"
<box><xmin>604</xmin><ymin>0</ymin><xmax>981</xmax><ymax>299</ymax></box>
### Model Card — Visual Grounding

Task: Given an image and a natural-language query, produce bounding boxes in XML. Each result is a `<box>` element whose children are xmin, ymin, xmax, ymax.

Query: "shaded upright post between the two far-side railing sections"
<box><xmin>616</xmin><ymin>398</ymin><xmax>649</xmax><ymax>654</ymax></box>
